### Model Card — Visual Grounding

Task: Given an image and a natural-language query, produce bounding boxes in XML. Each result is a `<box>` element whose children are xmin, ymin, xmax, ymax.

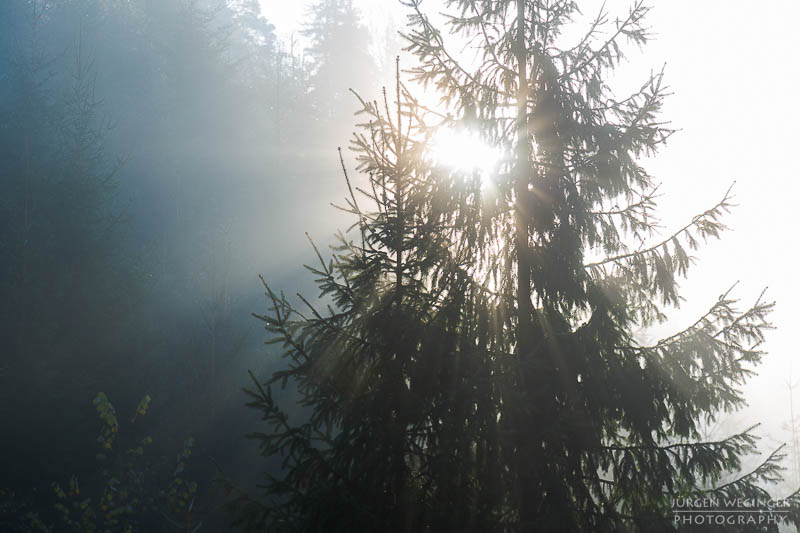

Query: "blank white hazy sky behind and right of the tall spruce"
<box><xmin>262</xmin><ymin>0</ymin><xmax>800</xmax><ymax>446</ymax></box>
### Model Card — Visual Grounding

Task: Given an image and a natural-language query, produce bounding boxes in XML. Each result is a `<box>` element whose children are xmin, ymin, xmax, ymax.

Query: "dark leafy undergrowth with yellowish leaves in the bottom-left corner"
<box><xmin>0</xmin><ymin>392</ymin><xmax>203</xmax><ymax>533</ymax></box>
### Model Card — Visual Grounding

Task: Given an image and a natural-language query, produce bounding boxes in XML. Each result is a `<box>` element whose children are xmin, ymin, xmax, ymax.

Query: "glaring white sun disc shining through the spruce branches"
<box><xmin>430</xmin><ymin>129</ymin><xmax>500</xmax><ymax>178</ymax></box>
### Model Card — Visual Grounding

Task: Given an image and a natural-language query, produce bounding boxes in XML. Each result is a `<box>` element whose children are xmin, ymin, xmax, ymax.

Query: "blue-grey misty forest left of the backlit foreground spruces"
<box><xmin>0</xmin><ymin>0</ymin><xmax>384</xmax><ymax>529</ymax></box>
